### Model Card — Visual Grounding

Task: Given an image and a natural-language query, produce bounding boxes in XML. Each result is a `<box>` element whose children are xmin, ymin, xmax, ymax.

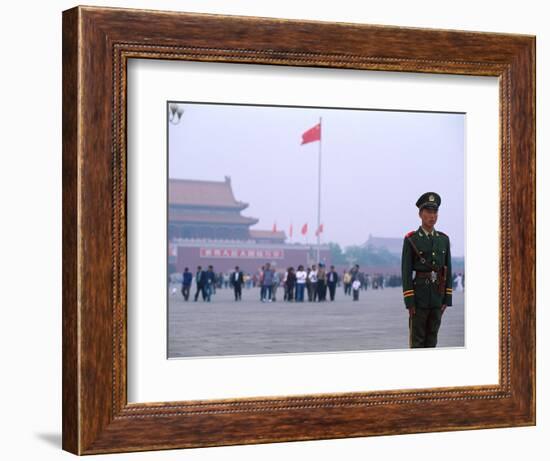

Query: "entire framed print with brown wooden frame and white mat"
<box><xmin>63</xmin><ymin>7</ymin><xmax>535</xmax><ymax>454</ymax></box>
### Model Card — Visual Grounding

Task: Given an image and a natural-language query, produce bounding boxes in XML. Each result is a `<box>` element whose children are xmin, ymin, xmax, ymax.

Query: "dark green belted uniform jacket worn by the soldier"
<box><xmin>401</xmin><ymin>227</ymin><xmax>453</xmax><ymax>309</ymax></box>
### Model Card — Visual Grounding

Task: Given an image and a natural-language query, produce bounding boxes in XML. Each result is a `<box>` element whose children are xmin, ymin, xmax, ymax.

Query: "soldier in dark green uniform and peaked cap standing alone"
<box><xmin>401</xmin><ymin>192</ymin><xmax>453</xmax><ymax>348</ymax></box>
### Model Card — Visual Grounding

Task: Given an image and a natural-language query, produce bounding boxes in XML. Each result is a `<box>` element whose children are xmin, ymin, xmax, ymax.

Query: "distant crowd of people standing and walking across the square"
<box><xmin>172</xmin><ymin>263</ymin><xmax>464</xmax><ymax>303</ymax></box>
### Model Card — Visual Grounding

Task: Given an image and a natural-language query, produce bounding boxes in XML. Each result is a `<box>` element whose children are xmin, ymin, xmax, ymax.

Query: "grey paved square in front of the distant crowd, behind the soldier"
<box><xmin>168</xmin><ymin>286</ymin><xmax>464</xmax><ymax>358</ymax></box>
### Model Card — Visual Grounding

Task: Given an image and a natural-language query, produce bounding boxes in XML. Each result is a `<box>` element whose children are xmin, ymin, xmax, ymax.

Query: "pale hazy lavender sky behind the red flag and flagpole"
<box><xmin>168</xmin><ymin>103</ymin><xmax>464</xmax><ymax>256</ymax></box>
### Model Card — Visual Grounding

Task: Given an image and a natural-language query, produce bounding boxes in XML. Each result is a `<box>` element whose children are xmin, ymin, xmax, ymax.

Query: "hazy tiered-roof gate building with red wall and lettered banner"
<box><xmin>168</xmin><ymin>176</ymin><xmax>330</xmax><ymax>272</ymax></box>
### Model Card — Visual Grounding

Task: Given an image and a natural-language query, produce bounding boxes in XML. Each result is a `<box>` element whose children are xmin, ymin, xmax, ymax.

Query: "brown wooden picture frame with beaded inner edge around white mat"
<box><xmin>63</xmin><ymin>7</ymin><xmax>535</xmax><ymax>454</ymax></box>
